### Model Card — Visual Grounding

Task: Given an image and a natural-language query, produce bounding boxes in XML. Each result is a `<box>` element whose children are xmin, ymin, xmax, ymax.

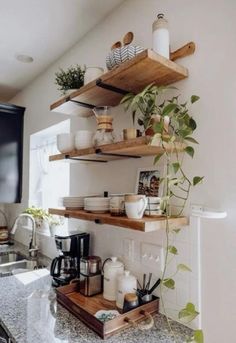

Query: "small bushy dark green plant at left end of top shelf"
<box><xmin>55</xmin><ymin>64</ymin><xmax>85</xmax><ymax>95</ymax></box>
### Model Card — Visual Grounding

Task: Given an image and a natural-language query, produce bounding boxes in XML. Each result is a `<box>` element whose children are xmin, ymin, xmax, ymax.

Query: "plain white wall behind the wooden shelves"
<box><xmin>5</xmin><ymin>0</ymin><xmax>236</xmax><ymax>343</ymax></box>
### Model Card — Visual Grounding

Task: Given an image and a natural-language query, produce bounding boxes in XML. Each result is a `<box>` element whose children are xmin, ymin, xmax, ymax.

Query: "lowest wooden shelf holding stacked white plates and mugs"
<box><xmin>49</xmin><ymin>208</ymin><xmax>188</xmax><ymax>232</ymax></box>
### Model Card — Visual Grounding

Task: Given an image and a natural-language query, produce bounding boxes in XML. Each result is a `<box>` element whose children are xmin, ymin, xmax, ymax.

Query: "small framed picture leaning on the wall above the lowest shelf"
<box><xmin>135</xmin><ymin>167</ymin><xmax>162</xmax><ymax>197</ymax></box>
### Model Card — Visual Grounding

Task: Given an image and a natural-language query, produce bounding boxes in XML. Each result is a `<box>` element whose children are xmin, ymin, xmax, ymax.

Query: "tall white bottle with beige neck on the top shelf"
<box><xmin>152</xmin><ymin>13</ymin><xmax>170</xmax><ymax>58</ymax></box>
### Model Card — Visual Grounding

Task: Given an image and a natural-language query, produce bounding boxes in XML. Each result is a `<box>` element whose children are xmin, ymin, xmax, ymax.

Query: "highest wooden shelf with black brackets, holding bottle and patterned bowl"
<box><xmin>50</xmin><ymin>49</ymin><xmax>188</xmax><ymax>117</ymax></box>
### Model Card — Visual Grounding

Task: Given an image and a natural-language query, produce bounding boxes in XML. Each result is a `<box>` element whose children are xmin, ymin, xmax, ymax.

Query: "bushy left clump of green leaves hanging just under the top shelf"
<box><xmin>121</xmin><ymin>84</ymin><xmax>170</xmax><ymax>136</ymax></box>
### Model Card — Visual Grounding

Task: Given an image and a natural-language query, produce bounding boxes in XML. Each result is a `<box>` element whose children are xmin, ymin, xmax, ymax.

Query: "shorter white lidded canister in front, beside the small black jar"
<box><xmin>116</xmin><ymin>270</ymin><xmax>137</xmax><ymax>309</ymax></box>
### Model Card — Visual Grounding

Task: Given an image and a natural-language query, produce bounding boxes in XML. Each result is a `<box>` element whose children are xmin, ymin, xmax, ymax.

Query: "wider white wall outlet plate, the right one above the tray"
<box><xmin>141</xmin><ymin>243</ymin><xmax>164</xmax><ymax>271</ymax></box>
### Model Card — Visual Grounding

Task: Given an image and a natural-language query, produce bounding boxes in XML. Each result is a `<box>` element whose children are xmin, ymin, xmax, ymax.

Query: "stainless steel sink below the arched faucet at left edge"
<box><xmin>0</xmin><ymin>252</ymin><xmax>38</xmax><ymax>277</ymax></box>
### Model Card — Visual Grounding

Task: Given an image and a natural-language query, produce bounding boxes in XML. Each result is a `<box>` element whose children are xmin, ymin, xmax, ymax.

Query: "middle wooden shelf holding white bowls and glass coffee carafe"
<box><xmin>49</xmin><ymin>136</ymin><xmax>185</xmax><ymax>162</ymax></box>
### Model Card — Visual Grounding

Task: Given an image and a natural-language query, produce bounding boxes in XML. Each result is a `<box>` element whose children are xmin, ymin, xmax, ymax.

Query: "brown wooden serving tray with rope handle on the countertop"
<box><xmin>56</xmin><ymin>284</ymin><xmax>159</xmax><ymax>339</ymax></box>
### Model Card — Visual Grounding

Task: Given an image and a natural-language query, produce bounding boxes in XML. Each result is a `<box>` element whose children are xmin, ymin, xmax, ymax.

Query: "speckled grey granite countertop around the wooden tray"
<box><xmin>0</xmin><ymin>245</ymin><xmax>191</xmax><ymax>343</ymax></box>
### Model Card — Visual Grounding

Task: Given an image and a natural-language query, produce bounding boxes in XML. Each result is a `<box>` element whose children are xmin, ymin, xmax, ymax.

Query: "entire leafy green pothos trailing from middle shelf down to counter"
<box><xmin>121</xmin><ymin>84</ymin><xmax>203</xmax><ymax>343</ymax></box>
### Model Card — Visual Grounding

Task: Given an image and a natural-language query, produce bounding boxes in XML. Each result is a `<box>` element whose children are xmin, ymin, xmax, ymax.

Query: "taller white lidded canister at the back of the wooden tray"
<box><xmin>103</xmin><ymin>257</ymin><xmax>124</xmax><ymax>301</ymax></box>
